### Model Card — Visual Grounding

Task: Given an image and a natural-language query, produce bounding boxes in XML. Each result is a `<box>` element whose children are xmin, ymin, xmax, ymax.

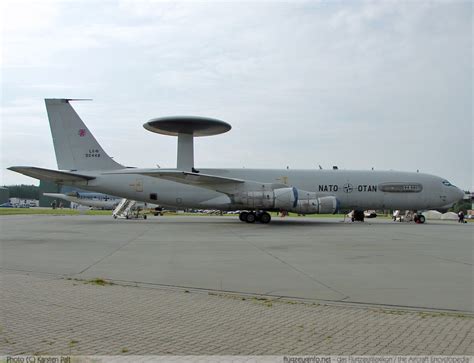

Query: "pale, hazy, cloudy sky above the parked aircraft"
<box><xmin>0</xmin><ymin>0</ymin><xmax>474</xmax><ymax>190</ymax></box>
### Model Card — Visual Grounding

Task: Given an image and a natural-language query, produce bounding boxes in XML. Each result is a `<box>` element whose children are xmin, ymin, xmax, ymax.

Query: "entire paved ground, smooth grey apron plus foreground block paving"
<box><xmin>0</xmin><ymin>216</ymin><xmax>474</xmax><ymax>355</ymax></box>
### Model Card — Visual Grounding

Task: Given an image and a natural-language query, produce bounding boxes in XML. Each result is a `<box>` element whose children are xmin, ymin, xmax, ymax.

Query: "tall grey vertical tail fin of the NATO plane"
<box><xmin>45</xmin><ymin>98</ymin><xmax>124</xmax><ymax>170</ymax></box>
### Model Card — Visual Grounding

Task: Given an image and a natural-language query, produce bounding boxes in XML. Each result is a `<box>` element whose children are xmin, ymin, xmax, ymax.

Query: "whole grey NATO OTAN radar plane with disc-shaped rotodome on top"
<box><xmin>9</xmin><ymin>99</ymin><xmax>463</xmax><ymax>223</ymax></box>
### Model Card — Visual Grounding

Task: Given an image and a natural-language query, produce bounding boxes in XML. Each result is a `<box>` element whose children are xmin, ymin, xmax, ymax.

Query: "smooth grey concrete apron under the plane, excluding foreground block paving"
<box><xmin>0</xmin><ymin>216</ymin><xmax>474</xmax><ymax>312</ymax></box>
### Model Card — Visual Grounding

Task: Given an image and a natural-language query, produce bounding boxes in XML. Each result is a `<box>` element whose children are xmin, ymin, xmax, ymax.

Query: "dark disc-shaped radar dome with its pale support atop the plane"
<box><xmin>143</xmin><ymin>116</ymin><xmax>231</xmax><ymax>173</ymax></box>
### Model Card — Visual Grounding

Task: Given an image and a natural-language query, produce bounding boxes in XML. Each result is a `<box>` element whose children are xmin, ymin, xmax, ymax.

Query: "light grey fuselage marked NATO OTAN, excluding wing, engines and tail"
<box><xmin>62</xmin><ymin>168</ymin><xmax>463</xmax><ymax>210</ymax></box>
